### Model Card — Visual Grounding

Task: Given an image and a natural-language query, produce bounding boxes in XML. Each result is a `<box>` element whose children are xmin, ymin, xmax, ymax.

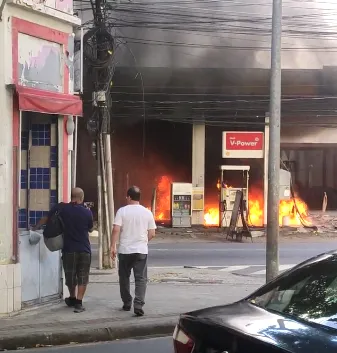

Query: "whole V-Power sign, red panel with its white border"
<box><xmin>222</xmin><ymin>131</ymin><xmax>264</xmax><ymax>158</ymax></box>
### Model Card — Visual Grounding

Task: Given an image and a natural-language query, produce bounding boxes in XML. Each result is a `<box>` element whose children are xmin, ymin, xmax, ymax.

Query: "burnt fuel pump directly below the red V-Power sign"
<box><xmin>217</xmin><ymin>165</ymin><xmax>250</xmax><ymax>228</ymax></box>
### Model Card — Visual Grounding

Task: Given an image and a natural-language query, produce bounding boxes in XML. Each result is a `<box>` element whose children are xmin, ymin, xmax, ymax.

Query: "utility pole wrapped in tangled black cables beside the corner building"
<box><xmin>82</xmin><ymin>0</ymin><xmax>115</xmax><ymax>268</ymax></box>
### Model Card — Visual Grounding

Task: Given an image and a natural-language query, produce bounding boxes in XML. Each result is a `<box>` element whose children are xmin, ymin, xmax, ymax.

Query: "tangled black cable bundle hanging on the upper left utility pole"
<box><xmin>79</xmin><ymin>0</ymin><xmax>145</xmax><ymax>137</ymax></box>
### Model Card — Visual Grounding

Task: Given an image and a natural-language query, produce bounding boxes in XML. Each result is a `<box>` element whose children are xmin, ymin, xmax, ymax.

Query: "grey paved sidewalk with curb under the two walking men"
<box><xmin>0</xmin><ymin>269</ymin><xmax>263</xmax><ymax>350</ymax></box>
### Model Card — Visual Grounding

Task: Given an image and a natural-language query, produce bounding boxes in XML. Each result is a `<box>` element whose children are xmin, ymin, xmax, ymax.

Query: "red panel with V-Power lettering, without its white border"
<box><xmin>226</xmin><ymin>132</ymin><xmax>263</xmax><ymax>151</ymax></box>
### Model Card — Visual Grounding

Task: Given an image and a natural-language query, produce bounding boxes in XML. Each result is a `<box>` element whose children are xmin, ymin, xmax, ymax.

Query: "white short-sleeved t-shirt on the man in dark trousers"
<box><xmin>114</xmin><ymin>205</ymin><xmax>157</xmax><ymax>254</ymax></box>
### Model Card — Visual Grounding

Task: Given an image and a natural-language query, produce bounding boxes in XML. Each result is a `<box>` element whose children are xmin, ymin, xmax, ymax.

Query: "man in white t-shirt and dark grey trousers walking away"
<box><xmin>111</xmin><ymin>186</ymin><xmax>157</xmax><ymax>316</ymax></box>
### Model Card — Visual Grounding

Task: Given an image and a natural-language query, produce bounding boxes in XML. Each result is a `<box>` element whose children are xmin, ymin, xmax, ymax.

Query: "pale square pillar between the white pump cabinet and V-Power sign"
<box><xmin>192</xmin><ymin>123</ymin><xmax>206</xmax><ymax>225</ymax></box>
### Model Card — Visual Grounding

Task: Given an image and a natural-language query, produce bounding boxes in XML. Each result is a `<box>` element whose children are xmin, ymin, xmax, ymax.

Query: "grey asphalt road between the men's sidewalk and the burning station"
<box><xmin>93</xmin><ymin>240</ymin><xmax>337</xmax><ymax>267</ymax></box>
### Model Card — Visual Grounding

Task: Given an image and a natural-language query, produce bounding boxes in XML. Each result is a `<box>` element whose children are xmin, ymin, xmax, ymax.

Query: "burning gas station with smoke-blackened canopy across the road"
<box><xmin>78</xmin><ymin>67</ymin><xmax>337</xmax><ymax>227</ymax></box>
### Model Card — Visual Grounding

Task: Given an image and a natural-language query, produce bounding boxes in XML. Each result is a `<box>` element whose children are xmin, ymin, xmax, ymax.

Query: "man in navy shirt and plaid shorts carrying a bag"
<box><xmin>34</xmin><ymin>188</ymin><xmax>94</xmax><ymax>313</ymax></box>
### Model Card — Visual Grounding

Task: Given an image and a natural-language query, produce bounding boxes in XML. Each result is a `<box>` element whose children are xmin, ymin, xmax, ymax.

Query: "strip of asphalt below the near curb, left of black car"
<box><xmin>25</xmin><ymin>337</ymin><xmax>173</xmax><ymax>353</ymax></box>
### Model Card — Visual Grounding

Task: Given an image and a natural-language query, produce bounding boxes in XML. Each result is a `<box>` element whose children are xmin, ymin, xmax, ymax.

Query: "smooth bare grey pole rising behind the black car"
<box><xmin>266</xmin><ymin>0</ymin><xmax>282</xmax><ymax>282</ymax></box>
